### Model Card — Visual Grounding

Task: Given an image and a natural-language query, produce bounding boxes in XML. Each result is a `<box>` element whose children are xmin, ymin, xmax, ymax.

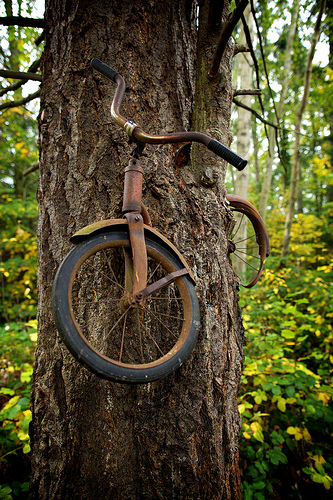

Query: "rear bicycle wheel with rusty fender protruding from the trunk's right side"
<box><xmin>227</xmin><ymin>195</ymin><xmax>269</xmax><ymax>288</ymax></box>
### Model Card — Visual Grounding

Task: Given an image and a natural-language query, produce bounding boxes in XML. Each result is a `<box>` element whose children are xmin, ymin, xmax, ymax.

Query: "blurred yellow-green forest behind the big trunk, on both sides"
<box><xmin>0</xmin><ymin>0</ymin><xmax>333</xmax><ymax>500</ymax></box>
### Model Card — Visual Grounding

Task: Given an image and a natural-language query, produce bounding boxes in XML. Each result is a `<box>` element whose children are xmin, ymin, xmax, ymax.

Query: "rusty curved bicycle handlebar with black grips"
<box><xmin>91</xmin><ymin>58</ymin><xmax>247</xmax><ymax>170</ymax></box>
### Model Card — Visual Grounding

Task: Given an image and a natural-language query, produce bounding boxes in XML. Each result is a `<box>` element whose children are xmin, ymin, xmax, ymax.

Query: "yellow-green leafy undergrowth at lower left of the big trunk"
<box><xmin>0</xmin><ymin>320</ymin><xmax>37</xmax><ymax>499</ymax></box>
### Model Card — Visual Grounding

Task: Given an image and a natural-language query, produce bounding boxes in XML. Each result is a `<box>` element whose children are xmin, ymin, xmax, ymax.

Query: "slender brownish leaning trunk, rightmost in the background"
<box><xmin>281</xmin><ymin>0</ymin><xmax>326</xmax><ymax>258</ymax></box>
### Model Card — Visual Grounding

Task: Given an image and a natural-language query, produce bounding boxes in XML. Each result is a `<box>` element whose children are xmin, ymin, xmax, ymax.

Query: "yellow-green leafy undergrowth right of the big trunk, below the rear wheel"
<box><xmin>239</xmin><ymin>214</ymin><xmax>333</xmax><ymax>500</ymax></box>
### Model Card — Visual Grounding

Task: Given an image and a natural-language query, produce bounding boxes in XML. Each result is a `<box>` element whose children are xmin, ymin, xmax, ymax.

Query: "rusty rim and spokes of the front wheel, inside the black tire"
<box><xmin>68</xmin><ymin>240</ymin><xmax>192</xmax><ymax>369</ymax></box>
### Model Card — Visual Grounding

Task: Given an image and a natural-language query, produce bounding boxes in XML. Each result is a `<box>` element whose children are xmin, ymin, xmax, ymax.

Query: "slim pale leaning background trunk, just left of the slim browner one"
<box><xmin>259</xmin><ymin>0</ymin><xmax>299</xmax><ymax>220</ymax></box>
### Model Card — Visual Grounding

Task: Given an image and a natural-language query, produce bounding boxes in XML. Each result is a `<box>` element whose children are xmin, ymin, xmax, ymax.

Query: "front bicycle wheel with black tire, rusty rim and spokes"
<box><xmin>52</xmin><ymin>229</ymin><xmax>199</xmax><ymax>383</ymax></box>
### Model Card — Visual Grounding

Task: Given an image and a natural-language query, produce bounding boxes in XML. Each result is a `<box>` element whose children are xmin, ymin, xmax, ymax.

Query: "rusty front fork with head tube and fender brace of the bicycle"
<box><xmin>122</xmin><ymin>158</ymin><xmax>189</xmax><ymax>308</ymax></box>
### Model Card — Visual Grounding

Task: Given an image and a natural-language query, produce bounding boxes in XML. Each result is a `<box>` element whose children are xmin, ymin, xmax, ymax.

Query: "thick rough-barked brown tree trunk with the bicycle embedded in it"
<box><xmin>31</xmin><ymin>0</ymin><xmax>243</xmax><ymax>500</ymax></box>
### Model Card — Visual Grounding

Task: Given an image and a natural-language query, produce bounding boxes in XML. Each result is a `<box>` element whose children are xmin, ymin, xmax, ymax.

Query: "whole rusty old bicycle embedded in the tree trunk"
<box><xmin>52</xmin><ymin>59</ymin><xmax>268</xmax><ymax>383</ymax></box>
